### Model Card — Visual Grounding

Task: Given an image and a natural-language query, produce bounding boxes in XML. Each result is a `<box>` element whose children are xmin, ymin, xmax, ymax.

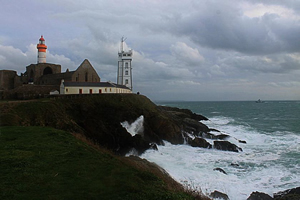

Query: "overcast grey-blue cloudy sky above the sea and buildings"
<box><xmin>0</xmin><ymin>0</ymin><xmax>300</xmax><ymax>101</ymax></box>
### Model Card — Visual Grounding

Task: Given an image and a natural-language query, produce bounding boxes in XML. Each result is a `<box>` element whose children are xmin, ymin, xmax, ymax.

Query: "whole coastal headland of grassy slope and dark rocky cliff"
<box><xmin>0</xmin><ymin>94</ymin><xmax>298</xmax><ymax>199</ymax></box>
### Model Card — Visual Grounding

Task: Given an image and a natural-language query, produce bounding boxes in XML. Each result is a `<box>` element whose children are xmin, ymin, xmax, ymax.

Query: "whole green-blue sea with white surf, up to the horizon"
<box><xmin>140</xmin><ymin>101</ymin><xmax>300</xmax><ymax>200</ymax></box>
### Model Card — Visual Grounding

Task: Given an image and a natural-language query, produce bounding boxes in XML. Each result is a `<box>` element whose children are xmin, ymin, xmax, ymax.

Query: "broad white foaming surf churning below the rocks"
<box><xmin>141</xmin><ymin>117</ymin><xmax>300</xmax><ymax>200</ymax></box>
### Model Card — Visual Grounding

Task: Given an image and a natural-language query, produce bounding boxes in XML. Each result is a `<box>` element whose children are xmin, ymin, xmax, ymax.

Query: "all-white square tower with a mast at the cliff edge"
<box><xmin>117</xmin><ymin>37</ymin><xmax>132</xmax><ymax>90</ymax></box>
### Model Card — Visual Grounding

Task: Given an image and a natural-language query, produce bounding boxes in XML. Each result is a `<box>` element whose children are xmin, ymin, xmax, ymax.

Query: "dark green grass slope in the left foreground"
<box><xmin>0</xmin><ymin>126</ymin><xmax>200</xmax><ymax>200</ymax></box>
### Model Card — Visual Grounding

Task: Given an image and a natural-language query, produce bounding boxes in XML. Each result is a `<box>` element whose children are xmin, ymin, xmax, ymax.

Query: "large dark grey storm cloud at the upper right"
<box><xmin>154</xmin><ymin>1</ymin><xmax>300</xmax><ymax>55</ymax></box>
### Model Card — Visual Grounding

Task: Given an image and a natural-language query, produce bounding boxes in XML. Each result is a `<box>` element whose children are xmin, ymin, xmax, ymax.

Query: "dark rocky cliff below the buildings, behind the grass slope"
<box><xmin>0</xmin><ymin>94</ymin><xmax>213</xmax><ymax>154</ymax></box>
